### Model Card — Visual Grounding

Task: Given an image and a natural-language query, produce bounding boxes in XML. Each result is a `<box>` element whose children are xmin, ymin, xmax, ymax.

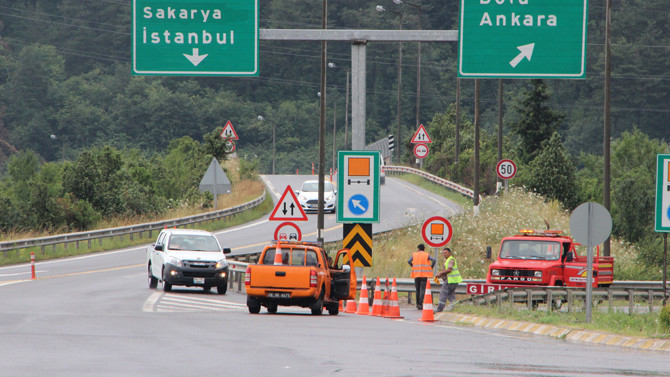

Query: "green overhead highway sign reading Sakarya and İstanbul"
<box><xmin>132</xmin><ymin>0</ymin><xmax>258</xmax><ymax>76</ymax></box>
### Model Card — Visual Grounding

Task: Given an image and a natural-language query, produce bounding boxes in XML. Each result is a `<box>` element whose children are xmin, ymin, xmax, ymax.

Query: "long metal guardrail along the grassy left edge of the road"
<box><xmin>0</xmin><ymin>190</ymin><xmax>266</xmax><ymax>256</ymax></box>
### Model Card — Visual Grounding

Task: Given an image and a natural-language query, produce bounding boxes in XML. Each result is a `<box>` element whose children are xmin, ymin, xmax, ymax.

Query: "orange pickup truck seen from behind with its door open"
<box><xmin>244</xmin><ymin>242</ymin><xmax>356</xmax><ymax>315</ymax></box>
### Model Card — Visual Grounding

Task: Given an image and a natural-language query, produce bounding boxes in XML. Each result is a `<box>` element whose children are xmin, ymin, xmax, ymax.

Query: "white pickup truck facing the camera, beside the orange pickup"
<box><xmin>147</xmin><ymin>229</ymin><xmax>230</xmax><ymax>295</ymax></box>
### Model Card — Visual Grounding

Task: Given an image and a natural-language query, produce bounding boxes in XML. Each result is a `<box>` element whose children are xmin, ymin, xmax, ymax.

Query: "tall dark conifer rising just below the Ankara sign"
<box><xmin>510</xmin><ymin>79</ymin><xmax>565</xmax><ymax>163</ymax></box>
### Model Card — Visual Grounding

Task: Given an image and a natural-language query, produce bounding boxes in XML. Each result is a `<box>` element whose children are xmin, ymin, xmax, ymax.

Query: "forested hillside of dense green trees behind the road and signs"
<box><xmin>0</xmin><ymin>0</ymin><xmax>670</xmax><ymax>264</ymax></box>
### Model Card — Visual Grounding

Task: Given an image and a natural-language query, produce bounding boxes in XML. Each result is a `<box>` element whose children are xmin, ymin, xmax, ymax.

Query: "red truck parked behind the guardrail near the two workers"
<box><xmin>478</xmin><ymin>230</ymin><xmax>614</xmax><ymax>293</ymax></box>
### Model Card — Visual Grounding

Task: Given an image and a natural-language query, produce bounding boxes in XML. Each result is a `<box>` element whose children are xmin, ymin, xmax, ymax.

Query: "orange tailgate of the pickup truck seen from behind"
<box><xmin>250</xmin><ymin>265</ymin><xmax>312</xmax><ymax>290</ymax></box>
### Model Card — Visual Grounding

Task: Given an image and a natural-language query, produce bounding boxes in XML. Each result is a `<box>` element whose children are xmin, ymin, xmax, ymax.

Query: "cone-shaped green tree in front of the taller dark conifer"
<box><xmin>525</xmin><ymin>132</ymin><xmax>578</xmax><ymax>209</ymax></box>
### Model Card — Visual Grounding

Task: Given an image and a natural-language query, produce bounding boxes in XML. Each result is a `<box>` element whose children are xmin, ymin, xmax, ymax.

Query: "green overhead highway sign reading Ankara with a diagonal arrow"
<box><xmin>458</xmin><ymin>0</ymin><xmax>588</xmax><ymax>78</ymax></box>
